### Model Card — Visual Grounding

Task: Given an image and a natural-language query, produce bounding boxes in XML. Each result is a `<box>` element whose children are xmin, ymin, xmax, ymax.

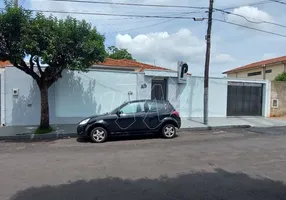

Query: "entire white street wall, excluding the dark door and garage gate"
<box><xmin>1</xmin><ymin>67</ymin><xmax>270</xmax><ymax>125</ymax></box>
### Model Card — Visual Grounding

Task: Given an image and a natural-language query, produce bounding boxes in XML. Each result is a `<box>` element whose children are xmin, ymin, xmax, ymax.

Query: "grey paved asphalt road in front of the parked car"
<box><xmin>0</xmin><ymin>129</ymin><xmax>286</xmax><ymax>200</ymax></box>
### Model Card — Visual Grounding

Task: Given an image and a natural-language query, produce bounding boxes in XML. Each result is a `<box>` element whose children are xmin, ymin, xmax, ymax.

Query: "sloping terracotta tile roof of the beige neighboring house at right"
<box><xmin>223</xmin><ymin>56</ymin><xmax>286</xmax><ymax>74</ymax></box>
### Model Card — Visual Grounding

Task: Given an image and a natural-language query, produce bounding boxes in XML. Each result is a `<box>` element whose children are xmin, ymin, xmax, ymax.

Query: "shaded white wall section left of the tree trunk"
<box><xmin>1</xmin><ymin>67</ymin><xmax>54</xmax><ymax>125</ymax></box>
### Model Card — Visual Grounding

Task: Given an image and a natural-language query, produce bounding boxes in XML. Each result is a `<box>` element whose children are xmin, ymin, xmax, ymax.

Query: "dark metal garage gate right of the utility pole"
<box><xmin>227</xmin><ymin>82</ymin><xmax>263</xmax><ymax>116</ymax></box>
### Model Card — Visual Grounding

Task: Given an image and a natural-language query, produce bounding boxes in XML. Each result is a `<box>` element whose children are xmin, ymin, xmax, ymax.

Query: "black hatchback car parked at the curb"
<box><xmin>77</xmin><ymin>100</ymin><xmax>181</xmax><ymax>143</ymax></box>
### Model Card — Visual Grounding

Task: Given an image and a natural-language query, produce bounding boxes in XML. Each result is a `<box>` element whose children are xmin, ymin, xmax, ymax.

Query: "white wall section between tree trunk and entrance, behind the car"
<box><xmin>55</xmin><ymin>70</ymin><xmax>137</xmax><ymax>117</ymax></box>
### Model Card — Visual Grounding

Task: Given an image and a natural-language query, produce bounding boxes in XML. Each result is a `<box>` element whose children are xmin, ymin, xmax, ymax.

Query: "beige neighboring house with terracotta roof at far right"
<box><xmin>223</xmin><ymin>56</ymin><xmax>286</xmax><ymax>81</ymax></box>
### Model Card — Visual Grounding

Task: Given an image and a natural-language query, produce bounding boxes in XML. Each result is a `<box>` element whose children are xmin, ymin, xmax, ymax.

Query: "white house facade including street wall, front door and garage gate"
<box><xmin>1</xmin><ymin>58</ymin><xmax>270</xmax><ymax>126</ymax></box>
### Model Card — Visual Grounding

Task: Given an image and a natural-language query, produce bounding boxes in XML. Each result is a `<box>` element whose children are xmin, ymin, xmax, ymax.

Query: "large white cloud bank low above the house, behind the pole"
<box><xmin>116</xmin><ymin>29</ymin><xmax>234</xmax><ymax>73</ymax></box>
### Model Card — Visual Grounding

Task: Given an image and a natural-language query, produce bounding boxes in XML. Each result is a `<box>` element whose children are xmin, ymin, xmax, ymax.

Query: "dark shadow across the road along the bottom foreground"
<box><xmin>11</xmin><ymin>169</ymin><xmax>286</xmax><ymax>200</ymax></box>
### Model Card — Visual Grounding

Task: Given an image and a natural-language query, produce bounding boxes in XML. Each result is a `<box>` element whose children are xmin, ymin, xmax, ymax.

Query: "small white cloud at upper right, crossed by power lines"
<box><xmin>227</xmin><ymin>6</ymin><xmax>273</xmax><ymax>27</ymax></box>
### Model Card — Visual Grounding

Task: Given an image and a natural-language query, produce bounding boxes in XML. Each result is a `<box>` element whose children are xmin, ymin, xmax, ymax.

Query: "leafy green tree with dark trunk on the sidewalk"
<box><xmin>0</xmin><ymin>4</ymin><xmax>106</xmax><ymax>129</ymax></box>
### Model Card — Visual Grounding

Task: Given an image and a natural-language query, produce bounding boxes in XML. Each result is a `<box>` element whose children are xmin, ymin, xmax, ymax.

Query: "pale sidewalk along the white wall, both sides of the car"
<box><xmin>0</xmin><ymin>117</ymin><xmax>286</xmax><ymax>140</ymax></box>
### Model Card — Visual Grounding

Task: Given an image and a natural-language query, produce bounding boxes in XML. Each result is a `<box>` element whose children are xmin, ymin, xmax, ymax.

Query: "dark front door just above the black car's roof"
<box><xmin>151</xmin><ymin>79</ymin><xmax>167</xmax><ymax>100</ymax></box>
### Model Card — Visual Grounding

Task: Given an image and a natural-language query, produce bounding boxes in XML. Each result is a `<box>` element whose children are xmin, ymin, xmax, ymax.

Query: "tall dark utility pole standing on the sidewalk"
<box><xmin>204</xmin><ymin>0</ymin><xmax>214</xmax><ymax>125</ymax></box>
